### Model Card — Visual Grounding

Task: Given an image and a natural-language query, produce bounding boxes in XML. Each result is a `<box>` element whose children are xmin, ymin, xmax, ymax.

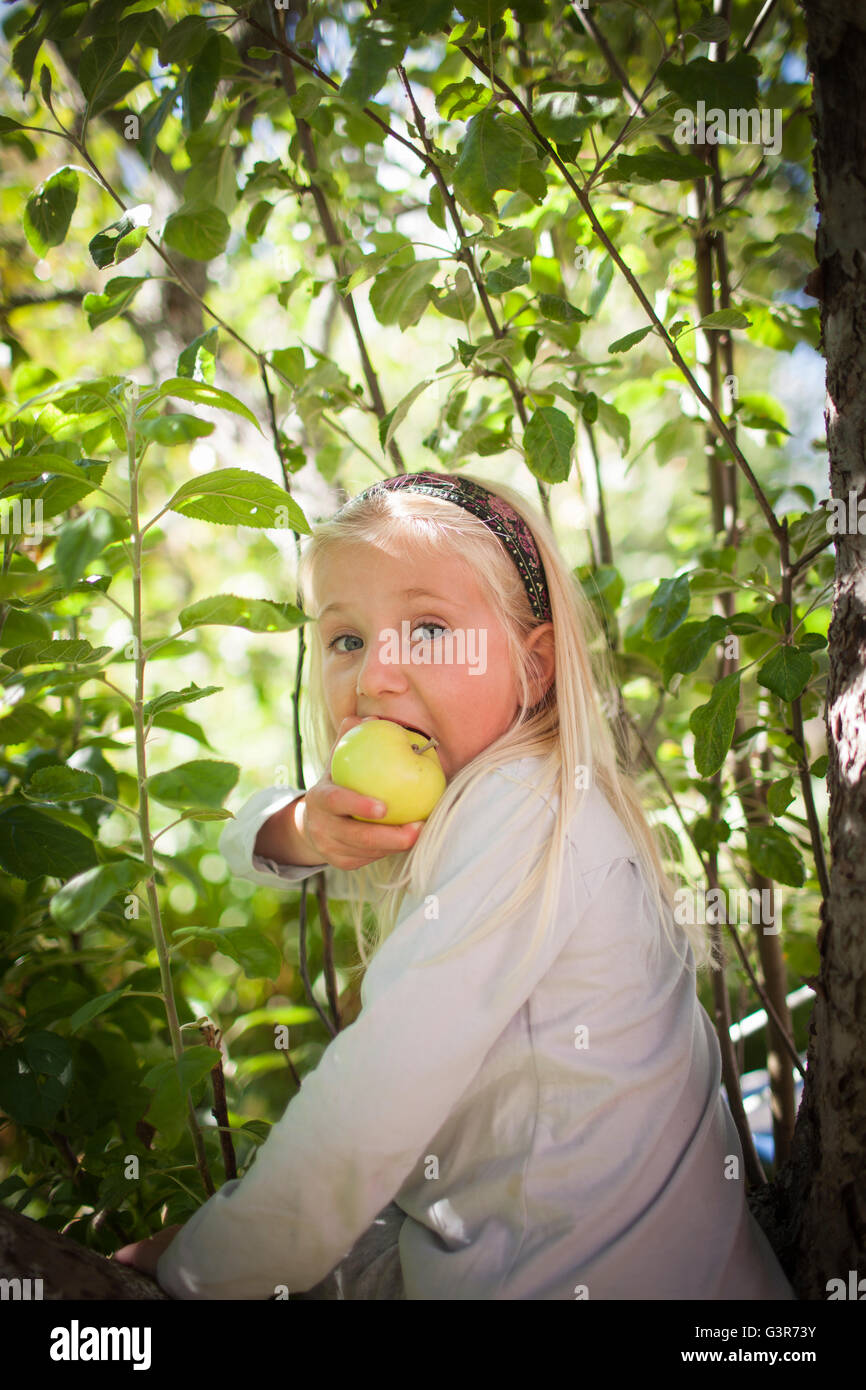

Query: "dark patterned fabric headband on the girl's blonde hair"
<box><xmin>346</xmin><ymin>473</ymin><xmax>552</xmax><ymax>623</ymax></box>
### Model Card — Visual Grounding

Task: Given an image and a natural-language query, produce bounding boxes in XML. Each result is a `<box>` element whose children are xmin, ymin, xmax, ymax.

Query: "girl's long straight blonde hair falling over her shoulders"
<box><xmin>299</xmin><ymin>470</ymin><xmax>712</xmax><ymax>1000</ymax></box>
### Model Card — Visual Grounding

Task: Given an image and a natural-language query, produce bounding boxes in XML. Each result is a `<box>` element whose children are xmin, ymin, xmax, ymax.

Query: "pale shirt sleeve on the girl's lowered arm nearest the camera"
<box><xmin>157</xmin><ymin>769</ymin><xmax>589</xmax><ymax>1298</ymax></box>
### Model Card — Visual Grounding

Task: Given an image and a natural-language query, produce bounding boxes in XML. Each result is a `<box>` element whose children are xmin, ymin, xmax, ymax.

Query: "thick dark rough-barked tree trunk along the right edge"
<box><xmin>752</xmin><ymin>0</ymin><xmax>866</xmax><ymax>1298</ymax></box>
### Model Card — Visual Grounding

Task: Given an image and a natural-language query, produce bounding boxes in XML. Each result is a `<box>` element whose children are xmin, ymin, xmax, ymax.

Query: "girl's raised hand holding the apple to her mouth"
<box><xmin>295</xmin><ymin>716</ymin><xmax>424</xmax><ymax>869</ymax></box>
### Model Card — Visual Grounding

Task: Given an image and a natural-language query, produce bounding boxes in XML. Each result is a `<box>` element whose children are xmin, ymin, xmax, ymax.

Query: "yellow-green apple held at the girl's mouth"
<box><xmin>331</xmin><ymin>719</ymin><xmax>446</xmax><ymax>826</ymax></box>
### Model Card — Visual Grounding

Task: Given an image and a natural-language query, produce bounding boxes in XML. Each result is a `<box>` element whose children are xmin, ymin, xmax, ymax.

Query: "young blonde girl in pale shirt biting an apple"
<box><xmin>118</xmin><ymin>473</ymin><xmax>794</xmax><ymax>1300</ymax></box>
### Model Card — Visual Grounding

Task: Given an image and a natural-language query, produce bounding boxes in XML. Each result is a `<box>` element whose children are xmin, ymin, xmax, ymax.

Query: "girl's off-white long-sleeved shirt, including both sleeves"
<box><xmin>157</xmin><ymin>758</ymin><xmax>795</xmax><ymax>1300</ymax></box>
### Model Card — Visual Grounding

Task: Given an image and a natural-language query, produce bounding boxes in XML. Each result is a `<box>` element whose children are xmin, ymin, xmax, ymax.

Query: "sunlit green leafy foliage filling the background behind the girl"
<box><xmin>0</xmin><ymin>0</ymin><xmax>833</xmax><ymax>1251</ymax></box>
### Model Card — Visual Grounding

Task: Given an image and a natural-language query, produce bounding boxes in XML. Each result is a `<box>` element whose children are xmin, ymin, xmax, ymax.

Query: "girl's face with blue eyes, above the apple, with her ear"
<box><xmin>316</xmin><ymin>542</ymin><xmax>553</xmax><ymax>781</ymax></box>
